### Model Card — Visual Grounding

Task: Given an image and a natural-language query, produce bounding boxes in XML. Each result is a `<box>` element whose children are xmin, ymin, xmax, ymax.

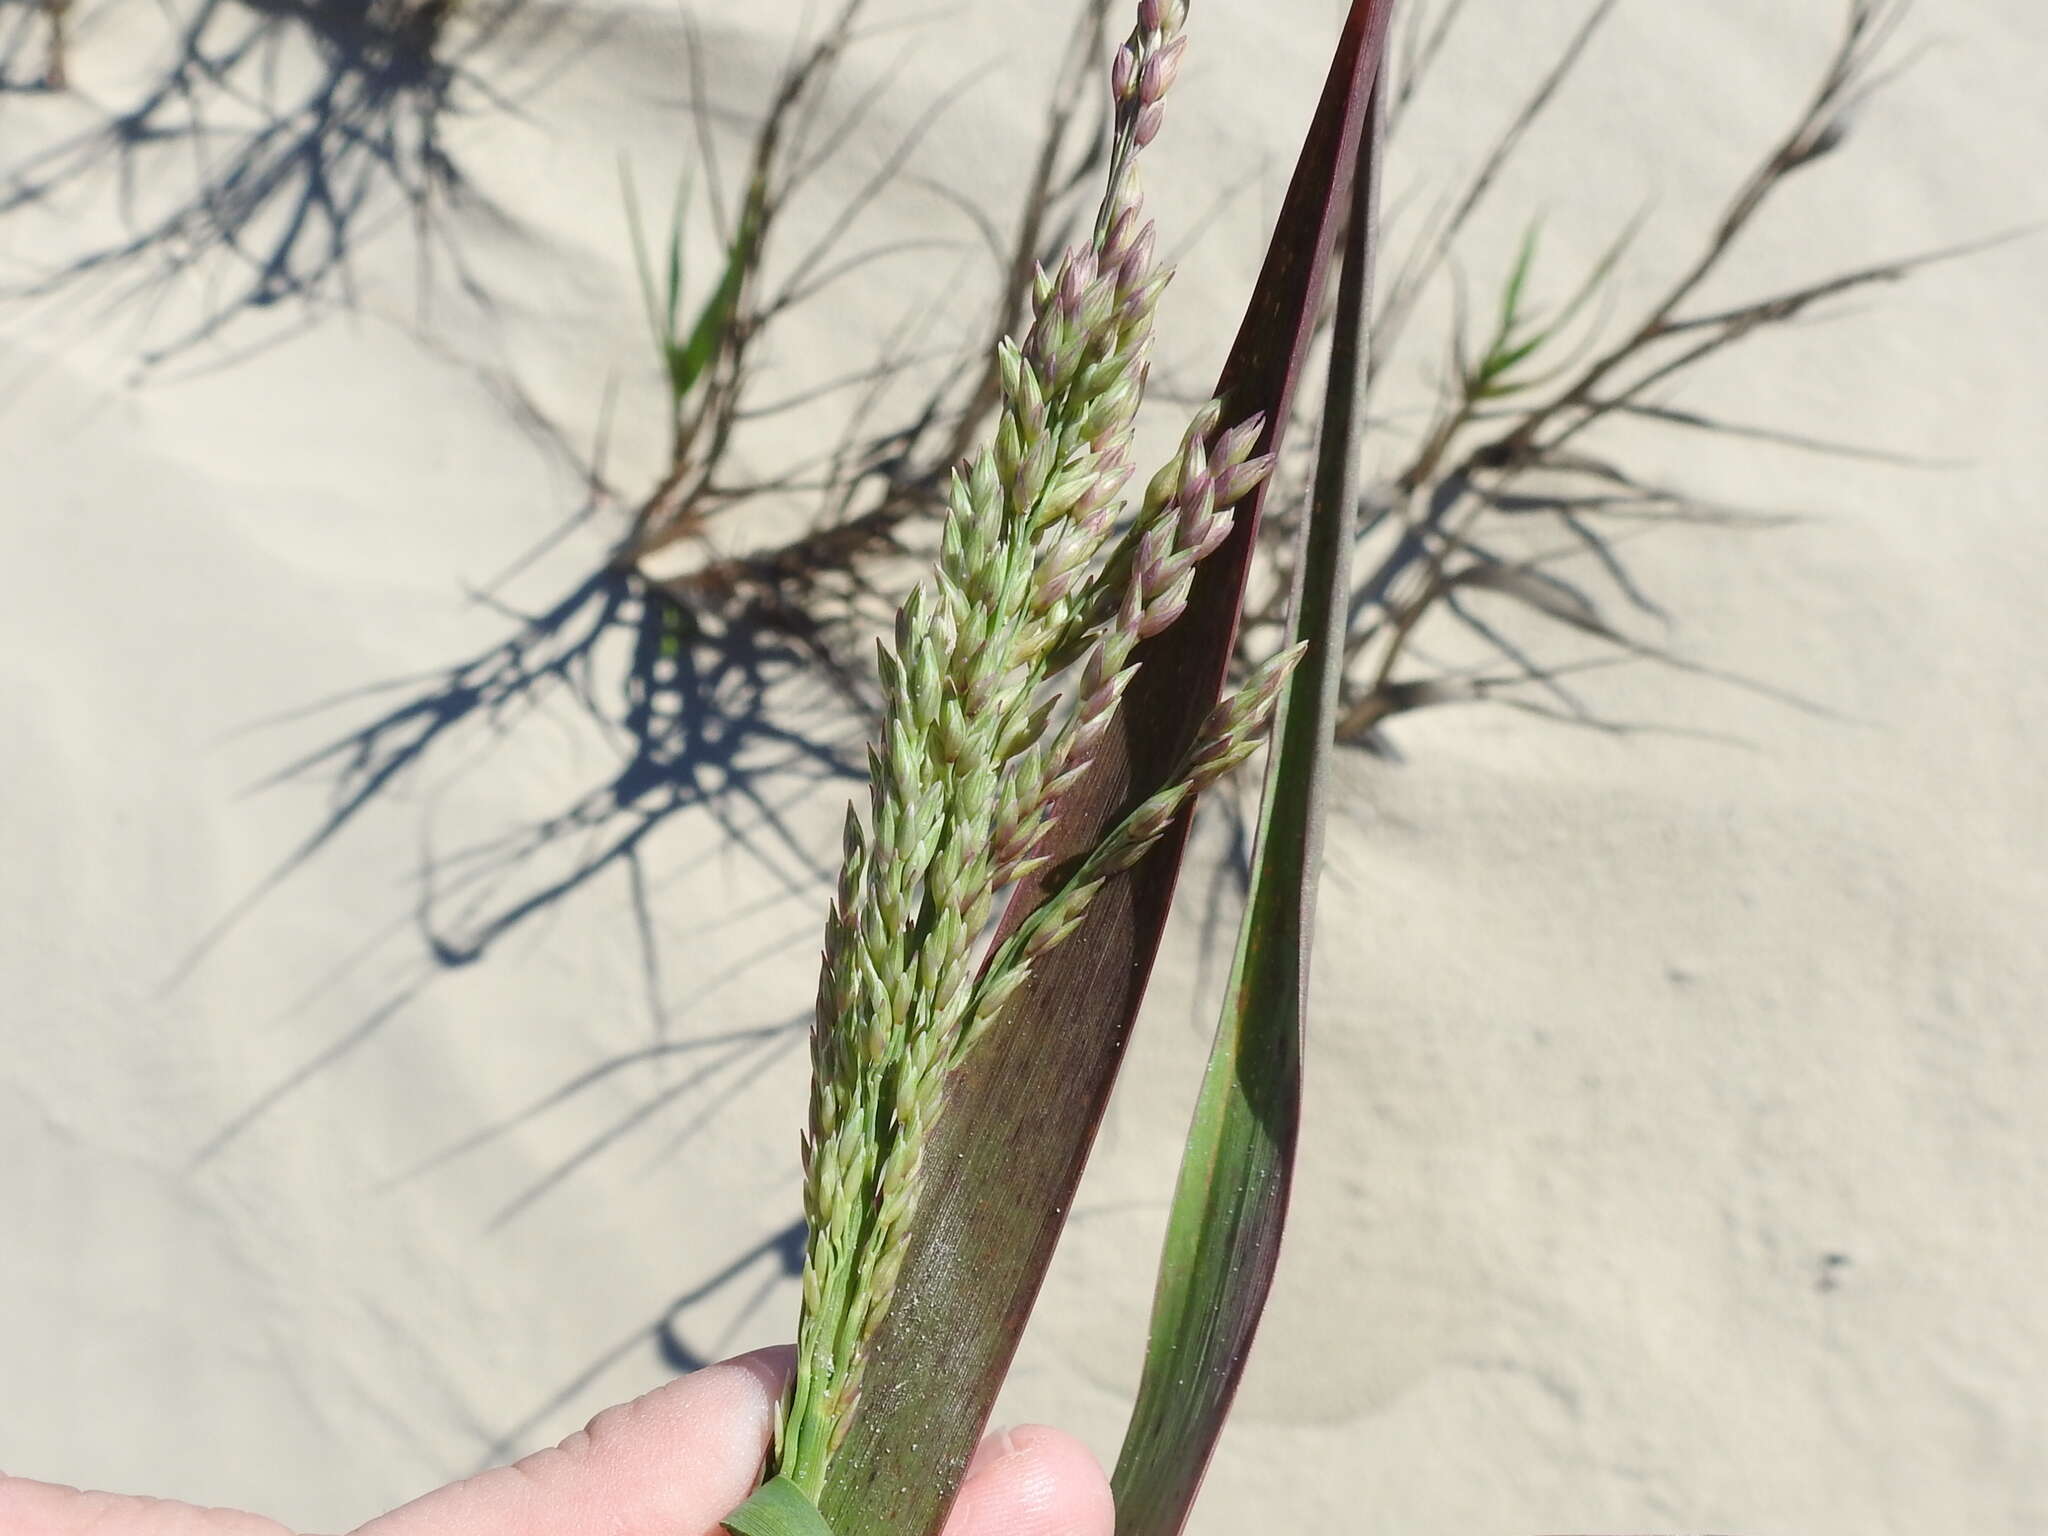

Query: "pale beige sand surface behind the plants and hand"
<box><xmin>0</xmin><ymin>0</ymin><xmax>2048</xmax><ymax>1536</ymax></box>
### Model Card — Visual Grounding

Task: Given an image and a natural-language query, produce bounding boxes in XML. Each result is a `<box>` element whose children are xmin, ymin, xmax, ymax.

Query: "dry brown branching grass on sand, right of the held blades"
<box><xmin>1337</xmin><ymin>0</ymin><xmax>1980</xmax><ymax>743</ymax></box>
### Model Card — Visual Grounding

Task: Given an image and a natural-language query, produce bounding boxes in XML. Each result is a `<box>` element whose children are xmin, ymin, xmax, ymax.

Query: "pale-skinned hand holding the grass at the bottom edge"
<box><xmin>0</xmin><ymin>1350</ymin><xmax>1114</xmax><ymax>1536</ymax></box>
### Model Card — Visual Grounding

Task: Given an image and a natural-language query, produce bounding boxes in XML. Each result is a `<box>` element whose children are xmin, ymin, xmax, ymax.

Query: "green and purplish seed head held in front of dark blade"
<box><xmin>776</xmin><ymin>0</ymin><xmax>1292</xmax><ymax>1501</ymax></box>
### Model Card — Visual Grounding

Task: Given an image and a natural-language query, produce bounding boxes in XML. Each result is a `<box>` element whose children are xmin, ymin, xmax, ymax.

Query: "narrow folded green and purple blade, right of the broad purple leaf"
<box><xmin>1114</xmin><ymin>51</ymin><xmax>1382</xmax><ymax>1536</ymax></box>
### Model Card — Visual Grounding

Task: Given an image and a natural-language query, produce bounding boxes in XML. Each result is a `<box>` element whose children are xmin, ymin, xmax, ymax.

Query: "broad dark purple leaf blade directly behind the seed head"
<box><xmin>819</xmin><ymin>12</ymin><xmax>1391</xmax><ymax>1536</ymax></box>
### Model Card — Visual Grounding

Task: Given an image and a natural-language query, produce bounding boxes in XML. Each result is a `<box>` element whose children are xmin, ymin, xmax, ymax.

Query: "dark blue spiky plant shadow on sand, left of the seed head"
<box><xmin>188</xmin><ymin>548</ymin><xmax>864</xmax><ymax>1187</ymax></box>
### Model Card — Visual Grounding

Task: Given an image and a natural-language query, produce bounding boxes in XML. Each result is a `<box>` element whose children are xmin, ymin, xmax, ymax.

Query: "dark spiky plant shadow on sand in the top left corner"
<box><xmin>0</xmin><ymin>0</ymin><xmax>577</xmax><ymax>369</ymax></box>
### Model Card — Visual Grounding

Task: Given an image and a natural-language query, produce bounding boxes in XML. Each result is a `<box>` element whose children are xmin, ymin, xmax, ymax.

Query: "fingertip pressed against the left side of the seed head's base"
<box><xmin>356</xmin><ymin>1348</ymin><xmax>795</xmax><ymax>1536</ymax></box>
